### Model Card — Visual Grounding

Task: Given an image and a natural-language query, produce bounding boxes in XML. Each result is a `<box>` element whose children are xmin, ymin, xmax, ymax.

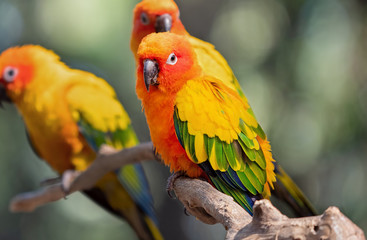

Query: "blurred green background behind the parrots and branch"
<box><xmin>0</xmin><ymin>0</ymin><xmax>367</xmax><ymax>240</ymax></box>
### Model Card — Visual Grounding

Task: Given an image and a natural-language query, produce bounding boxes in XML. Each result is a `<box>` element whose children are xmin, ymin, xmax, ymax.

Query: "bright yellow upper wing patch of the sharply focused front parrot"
<box><xmin>176</xmin><ymin>77</ymin><xmax>257</xmax><ymax>143</ymax></box>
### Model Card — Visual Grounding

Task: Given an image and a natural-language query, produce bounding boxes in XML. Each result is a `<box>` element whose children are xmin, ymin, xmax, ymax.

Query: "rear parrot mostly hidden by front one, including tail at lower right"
<box><xmin>130</xmin><ymin>0</ymin><xmax>317</xmax><ymax>216</ymax></box>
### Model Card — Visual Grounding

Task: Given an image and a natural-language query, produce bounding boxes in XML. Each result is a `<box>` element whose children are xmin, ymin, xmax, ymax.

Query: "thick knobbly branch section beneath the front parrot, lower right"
<box><xmin>173</xmin><ymin>177</ymin><xmax>365</xmax><ymax>240</ymax></box>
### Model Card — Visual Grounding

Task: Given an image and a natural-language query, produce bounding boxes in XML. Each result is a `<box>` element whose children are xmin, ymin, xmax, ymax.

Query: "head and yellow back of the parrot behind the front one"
<box><xmin>130</xmin><ymin>0</ymin><xmax>246</xmax><ymax>99</ymax></box>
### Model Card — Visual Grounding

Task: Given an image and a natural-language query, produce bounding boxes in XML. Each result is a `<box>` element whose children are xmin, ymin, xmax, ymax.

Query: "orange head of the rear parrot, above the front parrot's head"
<box><xmin>130</xmin><ymin>0</ymin><xmax>186</xmax><ymax>54</ymax></box>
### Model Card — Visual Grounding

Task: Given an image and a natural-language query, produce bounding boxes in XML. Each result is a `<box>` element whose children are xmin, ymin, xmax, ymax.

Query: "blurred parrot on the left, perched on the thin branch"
<box><xmin>0</xmin><ymin>45</ymin><xmax>162</xmax><ymax>240</ymax></box>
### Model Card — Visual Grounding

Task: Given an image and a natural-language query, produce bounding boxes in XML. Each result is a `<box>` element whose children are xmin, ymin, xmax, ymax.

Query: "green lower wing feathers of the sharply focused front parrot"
<box><xmin>174</xmin><ymin>109</ymin><xmax>266</xmax><ymax>213</ymax></box>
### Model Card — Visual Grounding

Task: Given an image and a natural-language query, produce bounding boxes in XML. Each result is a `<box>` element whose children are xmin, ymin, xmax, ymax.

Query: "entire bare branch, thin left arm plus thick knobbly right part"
<box><xmin>10</xmin><ymin>143</ymin><xmax>365</xmax><ymax>240</ymax></box>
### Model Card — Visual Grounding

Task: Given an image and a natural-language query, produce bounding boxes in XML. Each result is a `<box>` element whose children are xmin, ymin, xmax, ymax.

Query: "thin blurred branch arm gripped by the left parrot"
<box><xmin>9</xmin><ymin>142</ymin><xmax>157</xmax><ymax>212</ymax></box>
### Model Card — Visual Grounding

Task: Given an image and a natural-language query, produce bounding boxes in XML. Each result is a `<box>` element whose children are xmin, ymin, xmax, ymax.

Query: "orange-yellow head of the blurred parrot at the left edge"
<box><xmin>0</xmin><ymin>45</ymin><xmax>58</xmax><ymax>106</ymax></box>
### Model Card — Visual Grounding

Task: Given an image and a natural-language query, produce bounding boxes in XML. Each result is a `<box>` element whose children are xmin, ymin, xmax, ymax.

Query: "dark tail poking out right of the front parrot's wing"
<box><xmin>272</xmin><ymin>164</ymin><xmax>317</xmax><ymax>217</ymax></box>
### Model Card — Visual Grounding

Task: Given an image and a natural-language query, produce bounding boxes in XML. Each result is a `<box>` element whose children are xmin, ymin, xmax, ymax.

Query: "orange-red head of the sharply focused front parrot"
<box><xmin>137</xmin><ymin>32</ymin><xmax>202</xmax><ymax>94</ymax></box>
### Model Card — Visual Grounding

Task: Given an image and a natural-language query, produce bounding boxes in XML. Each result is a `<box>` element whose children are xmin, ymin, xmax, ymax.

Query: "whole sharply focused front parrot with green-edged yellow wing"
<box><xmin>136</xmin><ymin>32</ymin><xmax>315</xmax><ymax>215</ymax></box>
